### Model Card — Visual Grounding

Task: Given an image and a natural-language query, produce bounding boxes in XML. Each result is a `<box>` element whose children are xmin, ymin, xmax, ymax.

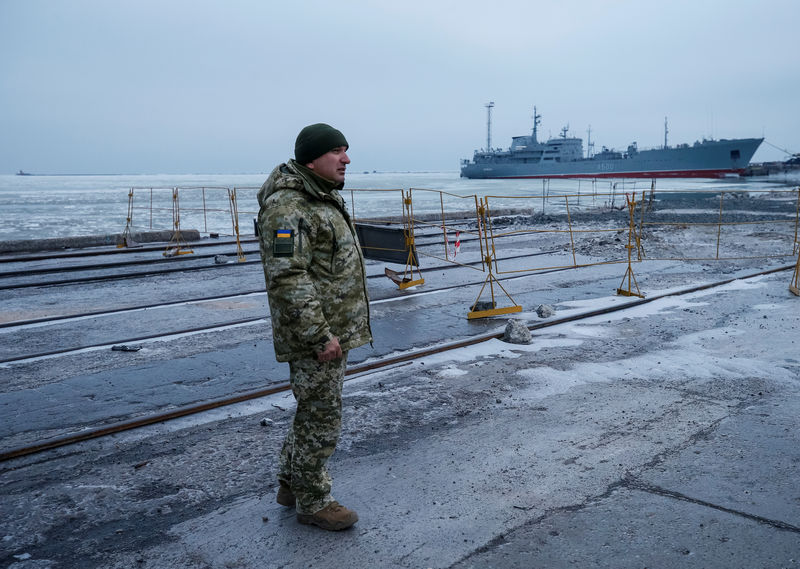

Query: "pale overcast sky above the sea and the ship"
<box><xmin>0</xmin><ymin>0</ymin><xmax>800</xmax><ymax>174</ymax></box>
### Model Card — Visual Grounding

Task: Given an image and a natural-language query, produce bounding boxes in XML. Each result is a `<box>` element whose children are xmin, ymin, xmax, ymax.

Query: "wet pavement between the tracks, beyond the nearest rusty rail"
<box><xmin>0</xmin><ymin>242</ymin><xmax>704</xmax><ymax>451</ymax></box>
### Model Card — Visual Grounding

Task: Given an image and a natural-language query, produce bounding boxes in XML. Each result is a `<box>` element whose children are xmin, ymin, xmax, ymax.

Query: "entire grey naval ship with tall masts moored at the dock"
<box><xmin>461</xmin><ymin>103</ymin><xmax>764</xmax><ymax>178</ymax></box>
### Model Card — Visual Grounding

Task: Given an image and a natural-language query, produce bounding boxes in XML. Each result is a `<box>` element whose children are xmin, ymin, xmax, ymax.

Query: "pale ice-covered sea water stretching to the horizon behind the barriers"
<box><xmin>0</xmin><ymin>171</ymin><xmax>797</xmax><ymax>241</ymax></box>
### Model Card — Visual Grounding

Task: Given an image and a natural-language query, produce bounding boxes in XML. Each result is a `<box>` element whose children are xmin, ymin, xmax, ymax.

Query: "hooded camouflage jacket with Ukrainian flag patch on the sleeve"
<box><xmin>258</xmin><ymin>160</ymin><xmax>372</xmax><ymax>362</ymax></box>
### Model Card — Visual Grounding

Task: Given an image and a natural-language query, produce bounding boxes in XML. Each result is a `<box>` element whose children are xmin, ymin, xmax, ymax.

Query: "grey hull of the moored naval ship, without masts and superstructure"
<box><xmin>461</xmin><ymin>138</ymin><xmax>763</xmax><ymax>179</ymax></box>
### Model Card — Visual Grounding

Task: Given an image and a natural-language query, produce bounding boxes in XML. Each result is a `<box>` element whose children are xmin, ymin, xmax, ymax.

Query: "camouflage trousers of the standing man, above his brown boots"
<box><xmin>278</xmin><ymin>352</ymin><xmax>347</xmax><ymax>514</ymax></box>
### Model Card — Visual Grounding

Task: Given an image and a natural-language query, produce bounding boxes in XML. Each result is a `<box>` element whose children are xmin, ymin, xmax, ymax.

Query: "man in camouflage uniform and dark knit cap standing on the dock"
<box><xmin>258</xmin><ymin>123</ymin><xmax>372</xmax><ymax>530</ymax></box>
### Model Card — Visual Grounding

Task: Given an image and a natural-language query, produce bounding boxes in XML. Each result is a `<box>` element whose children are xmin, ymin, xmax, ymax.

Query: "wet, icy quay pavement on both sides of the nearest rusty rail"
<box><xmin>0</xmin><ymin>220</ymin><xmax>800</xmax><ymax>569</ymax></box>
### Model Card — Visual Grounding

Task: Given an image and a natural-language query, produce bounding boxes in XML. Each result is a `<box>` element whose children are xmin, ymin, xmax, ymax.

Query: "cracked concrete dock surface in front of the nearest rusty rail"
<box><xmin>0</xmin><ymin>262</ymin><xmax>800</xmax><ymax>569</ymax></box>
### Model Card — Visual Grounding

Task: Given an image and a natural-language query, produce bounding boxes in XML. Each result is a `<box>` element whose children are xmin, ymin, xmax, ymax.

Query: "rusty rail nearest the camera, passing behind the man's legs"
<box><xmin>0</xmin><ymin>265</ymin><xmax>794</xmax><ymax>462</ymax></box>
